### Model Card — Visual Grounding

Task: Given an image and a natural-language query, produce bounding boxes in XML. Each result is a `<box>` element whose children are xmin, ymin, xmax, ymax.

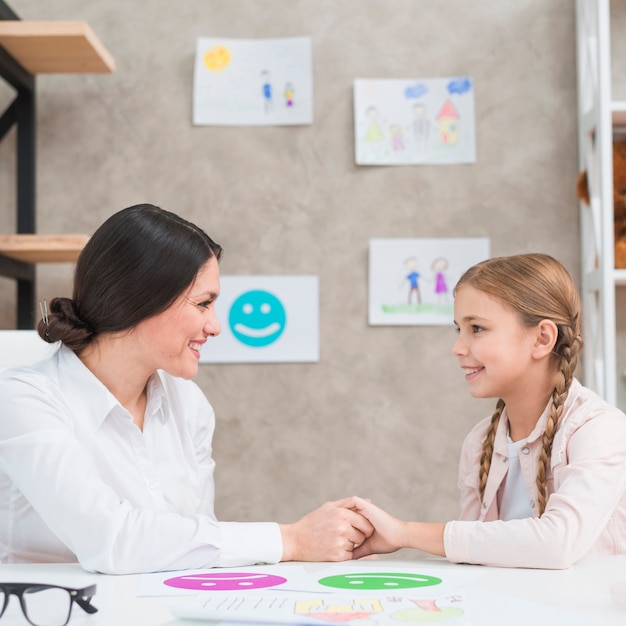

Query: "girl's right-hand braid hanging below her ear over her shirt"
<box><xmin>536</xmin><ymin>326</ymin><xmax>582</xmax><ymax>517</ymax></box>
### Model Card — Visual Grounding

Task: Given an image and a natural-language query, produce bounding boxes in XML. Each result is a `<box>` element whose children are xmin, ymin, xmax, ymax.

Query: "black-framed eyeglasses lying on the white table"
<box><xmin>0</xmin><ymin>583</ymin><xmax>98</xmax><ymax>626</ymax></box>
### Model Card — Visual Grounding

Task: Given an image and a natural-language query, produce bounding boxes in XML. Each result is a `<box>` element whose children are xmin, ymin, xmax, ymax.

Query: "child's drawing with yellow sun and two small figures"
<box><xmin>193</xmin><ymin>37</ymin><xmax>313</xmax><ymax>126</ymax></box>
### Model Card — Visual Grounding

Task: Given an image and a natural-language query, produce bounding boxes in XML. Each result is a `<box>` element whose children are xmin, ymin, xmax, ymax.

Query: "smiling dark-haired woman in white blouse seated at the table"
<box><xmin>0</xmin><ymin>204</ymin><xmax>372</xmax><ymax>574</ymax></box>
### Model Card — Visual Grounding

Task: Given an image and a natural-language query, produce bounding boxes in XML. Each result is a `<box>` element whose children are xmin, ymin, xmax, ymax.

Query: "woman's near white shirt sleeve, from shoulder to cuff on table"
<box><xmin>0</xmin><ymin>372</ymin><xmax>282</xmax><ymax>574</ymax></box>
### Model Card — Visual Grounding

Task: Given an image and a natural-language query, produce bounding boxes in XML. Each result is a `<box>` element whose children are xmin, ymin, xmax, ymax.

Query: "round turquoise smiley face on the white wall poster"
<box><xmin>228</xmin><ymin>290</ymin><xmax>287</xmax><ymax>348</ymax></box>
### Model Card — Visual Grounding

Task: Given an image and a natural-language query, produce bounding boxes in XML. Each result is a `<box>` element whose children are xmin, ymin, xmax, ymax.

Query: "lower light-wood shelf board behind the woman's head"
<box><xmin>0</xmin><ymin>235</ymin><xmax>89</xmax><ymax>263</ymax></box>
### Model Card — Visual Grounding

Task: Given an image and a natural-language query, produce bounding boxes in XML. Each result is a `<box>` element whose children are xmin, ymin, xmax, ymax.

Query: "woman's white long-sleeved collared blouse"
<box><xmin>0</xmin><ymin>347</ymin><xmax>283</xmax><ymax>574</ymax></box>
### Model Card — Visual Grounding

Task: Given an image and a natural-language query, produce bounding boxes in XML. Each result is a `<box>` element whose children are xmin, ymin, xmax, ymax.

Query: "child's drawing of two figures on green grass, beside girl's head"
<box><xmin>369</xmin><ymin>237</ymin><xmax>489</xmax><ymax>326</ymax></box>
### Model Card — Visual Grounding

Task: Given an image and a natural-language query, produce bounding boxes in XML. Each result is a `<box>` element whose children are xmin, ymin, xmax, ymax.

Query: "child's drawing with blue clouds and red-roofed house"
<box><xmin>354</xmin><ymin>77</ymin><xmax>476</xmax><ymax>165</ymax></box>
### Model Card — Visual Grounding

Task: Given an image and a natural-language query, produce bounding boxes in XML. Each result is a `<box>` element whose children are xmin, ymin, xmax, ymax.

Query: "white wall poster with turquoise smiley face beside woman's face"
<box><xmin>200</xmin><ymin>276</ymin><xmax>319</xmax><ymax>363</ymax></box>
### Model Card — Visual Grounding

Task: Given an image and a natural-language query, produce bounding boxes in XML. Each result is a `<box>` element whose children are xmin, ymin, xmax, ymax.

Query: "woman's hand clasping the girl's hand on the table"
<box><xmin>280</xmin><ymin>498</ymin><xmax>374</xmax><ymax>561</ymax></box>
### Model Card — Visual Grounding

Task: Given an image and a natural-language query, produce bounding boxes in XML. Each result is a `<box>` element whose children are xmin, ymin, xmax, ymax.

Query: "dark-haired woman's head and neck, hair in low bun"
<box><xmin>61</xmin><ymin>205</ymin><xmax>222</xmax><ymax>398</ymax></box>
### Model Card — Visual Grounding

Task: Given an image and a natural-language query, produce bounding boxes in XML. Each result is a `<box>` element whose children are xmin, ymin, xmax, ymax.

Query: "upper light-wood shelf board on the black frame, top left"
<box><xmin>0</xmin><ymin>20</ymin><xmax>115</xmax><ymax>74</ymax></box>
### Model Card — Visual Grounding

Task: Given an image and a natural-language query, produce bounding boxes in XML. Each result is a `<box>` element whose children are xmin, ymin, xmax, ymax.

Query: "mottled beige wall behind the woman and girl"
<box><xmin>0</xmin><ymin>0</ymin><xmax>579</xmax><ymax>532</ymax></box>
